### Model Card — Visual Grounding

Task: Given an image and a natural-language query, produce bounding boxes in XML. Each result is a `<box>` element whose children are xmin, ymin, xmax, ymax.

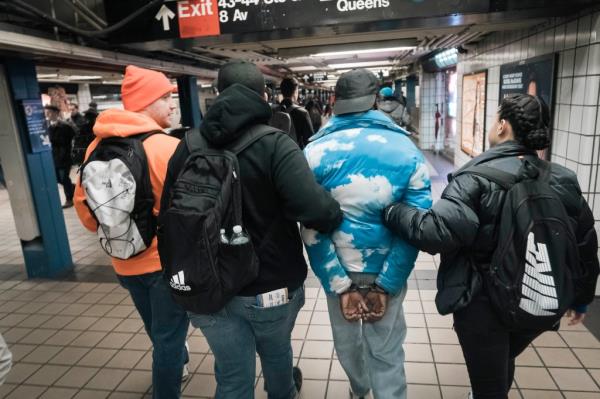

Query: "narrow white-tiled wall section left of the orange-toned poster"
<box><xmin>419</xmin><ymin>72</ymin><xmax>446</xmax><ymax>150</ymax></box>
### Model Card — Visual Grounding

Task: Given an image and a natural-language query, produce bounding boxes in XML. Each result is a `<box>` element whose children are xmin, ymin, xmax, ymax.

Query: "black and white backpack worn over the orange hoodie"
<box><xmin>79</xmin><ymin>132</ymin><xmax>157</xmax><ymax>259</ymax></box>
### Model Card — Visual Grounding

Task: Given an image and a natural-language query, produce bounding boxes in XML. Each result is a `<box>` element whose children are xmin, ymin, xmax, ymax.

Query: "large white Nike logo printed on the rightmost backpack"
<box><xmin>519</xmin><ymin>232</ymin><xmax>558</xmax><ymax>316</ymax></box>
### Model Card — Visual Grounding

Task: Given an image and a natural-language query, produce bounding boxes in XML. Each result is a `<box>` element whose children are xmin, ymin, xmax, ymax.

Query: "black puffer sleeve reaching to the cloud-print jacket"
<box><xmin>384</xmin><ymin>175</ymin><xmax>480</xmax><ymax>254</ymax></box>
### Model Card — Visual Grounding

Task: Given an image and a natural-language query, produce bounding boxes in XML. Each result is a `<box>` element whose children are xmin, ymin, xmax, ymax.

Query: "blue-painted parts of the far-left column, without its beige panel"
<box><xmin>0</xmin><ymin>58</ymin><xmax>73</xmax><ymax>278</ymax></box>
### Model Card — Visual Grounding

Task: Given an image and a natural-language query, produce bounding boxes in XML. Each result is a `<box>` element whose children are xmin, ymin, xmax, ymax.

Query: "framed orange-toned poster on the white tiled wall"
<box><xmin>460</xmin><ymin>71</ymin><xmax>487</xmax><ymax>157</ymax></box>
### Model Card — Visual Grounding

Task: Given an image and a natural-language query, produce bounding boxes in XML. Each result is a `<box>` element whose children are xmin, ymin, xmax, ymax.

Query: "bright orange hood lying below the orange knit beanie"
<box><xmin>94</xmin><ymin>109</ymin><xmax>163</xmax><ymax>139</ymax></box>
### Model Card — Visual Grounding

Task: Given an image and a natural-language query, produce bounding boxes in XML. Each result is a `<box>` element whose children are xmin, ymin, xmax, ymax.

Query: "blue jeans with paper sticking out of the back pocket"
<box><xmin>190</xmin><ymin>287</ymin><xmax>304</xmax><ymax>399</ymax></box>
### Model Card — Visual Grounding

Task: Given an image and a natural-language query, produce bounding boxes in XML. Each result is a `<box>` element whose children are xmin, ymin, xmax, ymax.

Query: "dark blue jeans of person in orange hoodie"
<box><xmin>117</xmin><ymin>272</ymin><xmax>189</xmax><ymax>399</ymax></box>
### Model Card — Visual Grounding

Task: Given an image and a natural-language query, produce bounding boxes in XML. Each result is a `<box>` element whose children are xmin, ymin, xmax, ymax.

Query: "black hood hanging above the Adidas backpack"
<box><xmin>200</xmin><ymin>83</ymin><xmax>272</xmax><ymax>147</ymax></box>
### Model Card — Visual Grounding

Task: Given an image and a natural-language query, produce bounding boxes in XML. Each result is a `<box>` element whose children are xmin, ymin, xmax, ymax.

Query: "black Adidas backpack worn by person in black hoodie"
<box><xmin>158</xmin><ymin>125</ymin><xmax>279</xmax><ymax>314</ymax></box>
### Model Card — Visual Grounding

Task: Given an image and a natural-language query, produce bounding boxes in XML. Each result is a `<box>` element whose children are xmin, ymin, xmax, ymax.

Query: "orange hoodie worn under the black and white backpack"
<box><xmin>73</xmin><ymin>109</ymin><xmax>179</xmax><ymax>276</ymax></box>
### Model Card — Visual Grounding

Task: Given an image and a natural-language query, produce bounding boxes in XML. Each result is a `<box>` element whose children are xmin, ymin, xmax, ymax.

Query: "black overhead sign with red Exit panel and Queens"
<box><xmin>104</xmin><ymin>0</ymin><xmax>490</xmax><ymax>43</ymax></box>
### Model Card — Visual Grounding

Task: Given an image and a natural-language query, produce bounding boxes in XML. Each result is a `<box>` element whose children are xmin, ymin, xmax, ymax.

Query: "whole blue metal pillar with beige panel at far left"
<box><xmin>0</xmin><ymin>58</ymin><xmax>73</xmax><ymax>278</ymax></box>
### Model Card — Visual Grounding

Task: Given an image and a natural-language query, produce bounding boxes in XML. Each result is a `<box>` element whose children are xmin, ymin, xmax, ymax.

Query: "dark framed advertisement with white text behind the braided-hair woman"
<box><xmin>500</xmin><ymin>54</ymin><xmax>557</xmax><ymax>160</ymax></box>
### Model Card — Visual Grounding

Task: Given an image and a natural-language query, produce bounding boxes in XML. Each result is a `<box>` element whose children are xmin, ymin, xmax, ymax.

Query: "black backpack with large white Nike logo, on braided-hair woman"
<box><xmin>460</xmin><ymin>160</ymin><xmax>583</xmax><ymax>330</ymax></box>
